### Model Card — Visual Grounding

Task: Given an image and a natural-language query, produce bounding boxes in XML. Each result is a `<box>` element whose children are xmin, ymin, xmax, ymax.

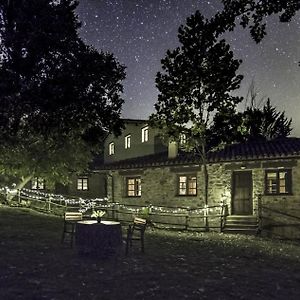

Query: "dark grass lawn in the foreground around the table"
<box><xmin>0</xmin><ymin>206</ymin><xmax>300</xmax><ymax>300</ymax></box>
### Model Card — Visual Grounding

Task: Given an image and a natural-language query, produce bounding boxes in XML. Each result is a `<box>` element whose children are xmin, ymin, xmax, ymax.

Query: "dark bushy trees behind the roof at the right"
<box><xmin>209</xmin><ymin>86</ymin><xmax>292</xmax><ymax>147</ymax></box>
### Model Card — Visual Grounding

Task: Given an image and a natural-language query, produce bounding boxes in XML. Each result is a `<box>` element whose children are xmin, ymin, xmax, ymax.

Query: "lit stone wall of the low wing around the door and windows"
<box><xmin>107</xmin><ymin>159</ymin><xmax>300</xmax><ymax>238</ymax></box>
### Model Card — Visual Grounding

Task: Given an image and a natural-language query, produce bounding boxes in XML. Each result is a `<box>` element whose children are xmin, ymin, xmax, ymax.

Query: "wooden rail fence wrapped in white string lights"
<box><xmin>2</xmin><ymin>189</ymin><xmax>227</xmax><ymax>231</ymax></box>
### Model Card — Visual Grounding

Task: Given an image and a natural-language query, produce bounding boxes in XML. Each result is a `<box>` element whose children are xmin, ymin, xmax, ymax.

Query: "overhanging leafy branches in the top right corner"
<box><xmin>214</xmin><ymin>0</ymin><xmax>300</xmax><ymax>43</ymax></box>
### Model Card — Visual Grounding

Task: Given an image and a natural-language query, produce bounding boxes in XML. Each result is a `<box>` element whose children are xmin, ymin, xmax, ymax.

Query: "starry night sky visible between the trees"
<box><xmin>77</xmin><ymin>0</ymin><xmax>300</xmax><ymax>137</ymax></box>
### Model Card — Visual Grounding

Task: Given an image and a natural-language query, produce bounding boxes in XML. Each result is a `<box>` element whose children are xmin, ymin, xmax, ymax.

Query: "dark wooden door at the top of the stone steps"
<box><xmin>232</xmin><ymin>171</ymin><xmax>253</xmax><ymax>215</ymax></box>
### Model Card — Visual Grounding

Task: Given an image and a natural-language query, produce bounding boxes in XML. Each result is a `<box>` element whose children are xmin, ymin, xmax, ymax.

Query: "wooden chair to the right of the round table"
<box><xmin>126</xmin><ymin>218</ymin><xmax>147</xmax><ymax>255</ymax></box>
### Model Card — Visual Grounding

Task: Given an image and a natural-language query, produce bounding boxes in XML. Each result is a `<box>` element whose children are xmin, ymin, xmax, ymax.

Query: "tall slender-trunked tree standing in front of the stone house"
<box><xmin>150</xmin><ymin>11</ymin><xmax>242</xmax><ymax>216</ymax></box>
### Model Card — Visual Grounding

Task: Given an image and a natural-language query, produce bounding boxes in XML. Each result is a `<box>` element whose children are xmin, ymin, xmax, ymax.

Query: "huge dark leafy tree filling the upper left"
<box><xmin>0</xmin><ymin>0</ymin><xmax>125</xmax><ymax>196</ymax></box>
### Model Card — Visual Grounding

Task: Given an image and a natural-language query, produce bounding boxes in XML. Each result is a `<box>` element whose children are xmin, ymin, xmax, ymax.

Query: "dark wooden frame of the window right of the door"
<box><xmin>265</xmin><ymin>169</ymin><xmax>292</xmax><ymax>196</ymax></box>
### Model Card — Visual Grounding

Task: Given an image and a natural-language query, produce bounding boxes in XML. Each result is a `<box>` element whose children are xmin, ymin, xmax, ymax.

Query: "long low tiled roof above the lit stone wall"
<box><xmin>99</xmin><ymin>138</ymin><xmax>300</xmax><ymax>170</ymax></box>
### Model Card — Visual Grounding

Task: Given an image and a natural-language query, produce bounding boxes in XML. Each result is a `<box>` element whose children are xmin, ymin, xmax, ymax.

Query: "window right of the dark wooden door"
<box><xmin>265</xmin><ymin>169</ymin><xmax>292</xmax><ymax>195</ymax></box>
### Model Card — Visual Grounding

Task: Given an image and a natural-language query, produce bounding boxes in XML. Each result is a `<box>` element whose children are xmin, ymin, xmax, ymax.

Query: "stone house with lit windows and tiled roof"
<box><xmin>27</xmin><ymin>119</ymin><xmax>300</xmax><ymax>238</ymax></box>
